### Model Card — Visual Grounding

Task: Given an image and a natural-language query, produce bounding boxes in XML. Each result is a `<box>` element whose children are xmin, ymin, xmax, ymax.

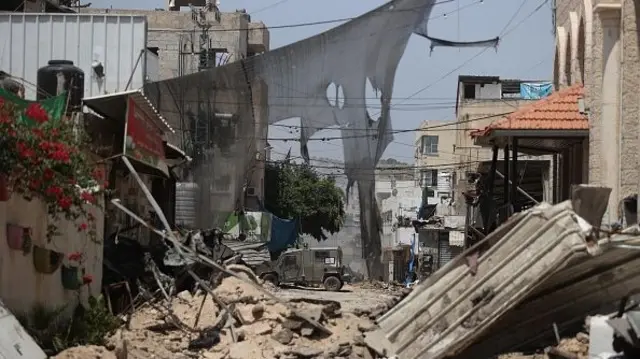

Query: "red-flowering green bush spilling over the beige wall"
<box><xmin>0</xmin><ymin>89</ymin><xmax>103</xmax><ymax>241</ymax></box>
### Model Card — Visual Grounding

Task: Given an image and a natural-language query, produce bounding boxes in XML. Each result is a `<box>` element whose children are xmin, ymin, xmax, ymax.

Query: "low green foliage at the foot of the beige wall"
<box><xmin>16</xmin><ymin>296</ymin><xmax>120</xmax><ymax>355</ymax></box>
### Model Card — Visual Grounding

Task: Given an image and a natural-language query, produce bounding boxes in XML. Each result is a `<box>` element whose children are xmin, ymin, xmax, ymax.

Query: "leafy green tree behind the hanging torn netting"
<box><xmin>264</xmin><ymin>161</ymin><xmax>345</xmax><ymax>240</ymax></box>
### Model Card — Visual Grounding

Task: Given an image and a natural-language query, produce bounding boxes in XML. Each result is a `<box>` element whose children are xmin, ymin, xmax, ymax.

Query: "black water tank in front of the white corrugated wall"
<box><xmin>37</xmin><ymin>60</ymin><xmax>84</xmax><ymax>113</ymax></box>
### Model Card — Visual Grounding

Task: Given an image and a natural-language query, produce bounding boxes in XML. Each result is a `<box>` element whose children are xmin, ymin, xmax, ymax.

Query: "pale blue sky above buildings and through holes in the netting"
<box><xmin>90</xmin><ymin>0</ymin><xmax>555</xmax><ymax>163</ymax></box>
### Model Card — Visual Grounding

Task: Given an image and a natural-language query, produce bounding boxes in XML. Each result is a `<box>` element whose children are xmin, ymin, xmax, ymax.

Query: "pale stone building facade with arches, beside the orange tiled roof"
<box><xmin>554</xmin><ymin>0</ymin><xmax>640</xmax><ymax>223</ymax></box>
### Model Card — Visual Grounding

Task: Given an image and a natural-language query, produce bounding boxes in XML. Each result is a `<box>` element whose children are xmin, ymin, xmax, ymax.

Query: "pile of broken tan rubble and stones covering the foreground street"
<box><xmin>55</xmin><ymin>277</ymin><xmax>400</xmax><ymax>359</ymax></box>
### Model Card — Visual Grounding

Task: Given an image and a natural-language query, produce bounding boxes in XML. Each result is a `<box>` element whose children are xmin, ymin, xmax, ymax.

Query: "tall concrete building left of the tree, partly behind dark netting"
<box><xmin>81</xmin><ymin>8</ymin><xmax>269</xmax><ymax>221</ymax></box>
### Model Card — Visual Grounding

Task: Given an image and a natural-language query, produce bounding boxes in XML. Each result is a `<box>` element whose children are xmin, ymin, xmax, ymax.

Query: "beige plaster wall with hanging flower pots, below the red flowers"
<box><xmin>0</xmin><ymin>195</ymin><xmax>104</xmax><ymax>314</ymax></box>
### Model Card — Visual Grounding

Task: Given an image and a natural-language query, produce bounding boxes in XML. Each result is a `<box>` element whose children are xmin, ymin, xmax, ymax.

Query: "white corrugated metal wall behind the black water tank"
<box><xmin>0</xmin><ymin>13</ymin><xmax>147</xmax><ymax>99</ymax></box>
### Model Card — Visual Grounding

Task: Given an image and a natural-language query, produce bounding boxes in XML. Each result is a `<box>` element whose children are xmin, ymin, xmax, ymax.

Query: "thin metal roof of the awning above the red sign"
<box><xmin>82</xmin><ymin>90</ymin><xmax>176</xmax><ymax>133</ymax></box>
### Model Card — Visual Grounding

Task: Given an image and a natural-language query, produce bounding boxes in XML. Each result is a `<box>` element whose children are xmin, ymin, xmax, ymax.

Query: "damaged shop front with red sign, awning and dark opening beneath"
<box><xmin>83</xmin><ymin>90</ymin><xmax>189</xmax><ymax>306</ymax></box>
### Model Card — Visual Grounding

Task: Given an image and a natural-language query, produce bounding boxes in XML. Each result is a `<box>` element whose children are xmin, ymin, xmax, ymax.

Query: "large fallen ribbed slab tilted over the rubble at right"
<box><xmin>366</xmin><ymin>201</ymin><xmax>640</xmax><ymax>359</ymax></box>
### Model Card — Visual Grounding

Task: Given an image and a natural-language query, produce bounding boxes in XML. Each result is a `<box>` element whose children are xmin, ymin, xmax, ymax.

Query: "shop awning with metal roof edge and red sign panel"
<box><xmin>83</xmin><ymin>90</ymin><xmax>178</xmax><ymax>177</ymax></box>
